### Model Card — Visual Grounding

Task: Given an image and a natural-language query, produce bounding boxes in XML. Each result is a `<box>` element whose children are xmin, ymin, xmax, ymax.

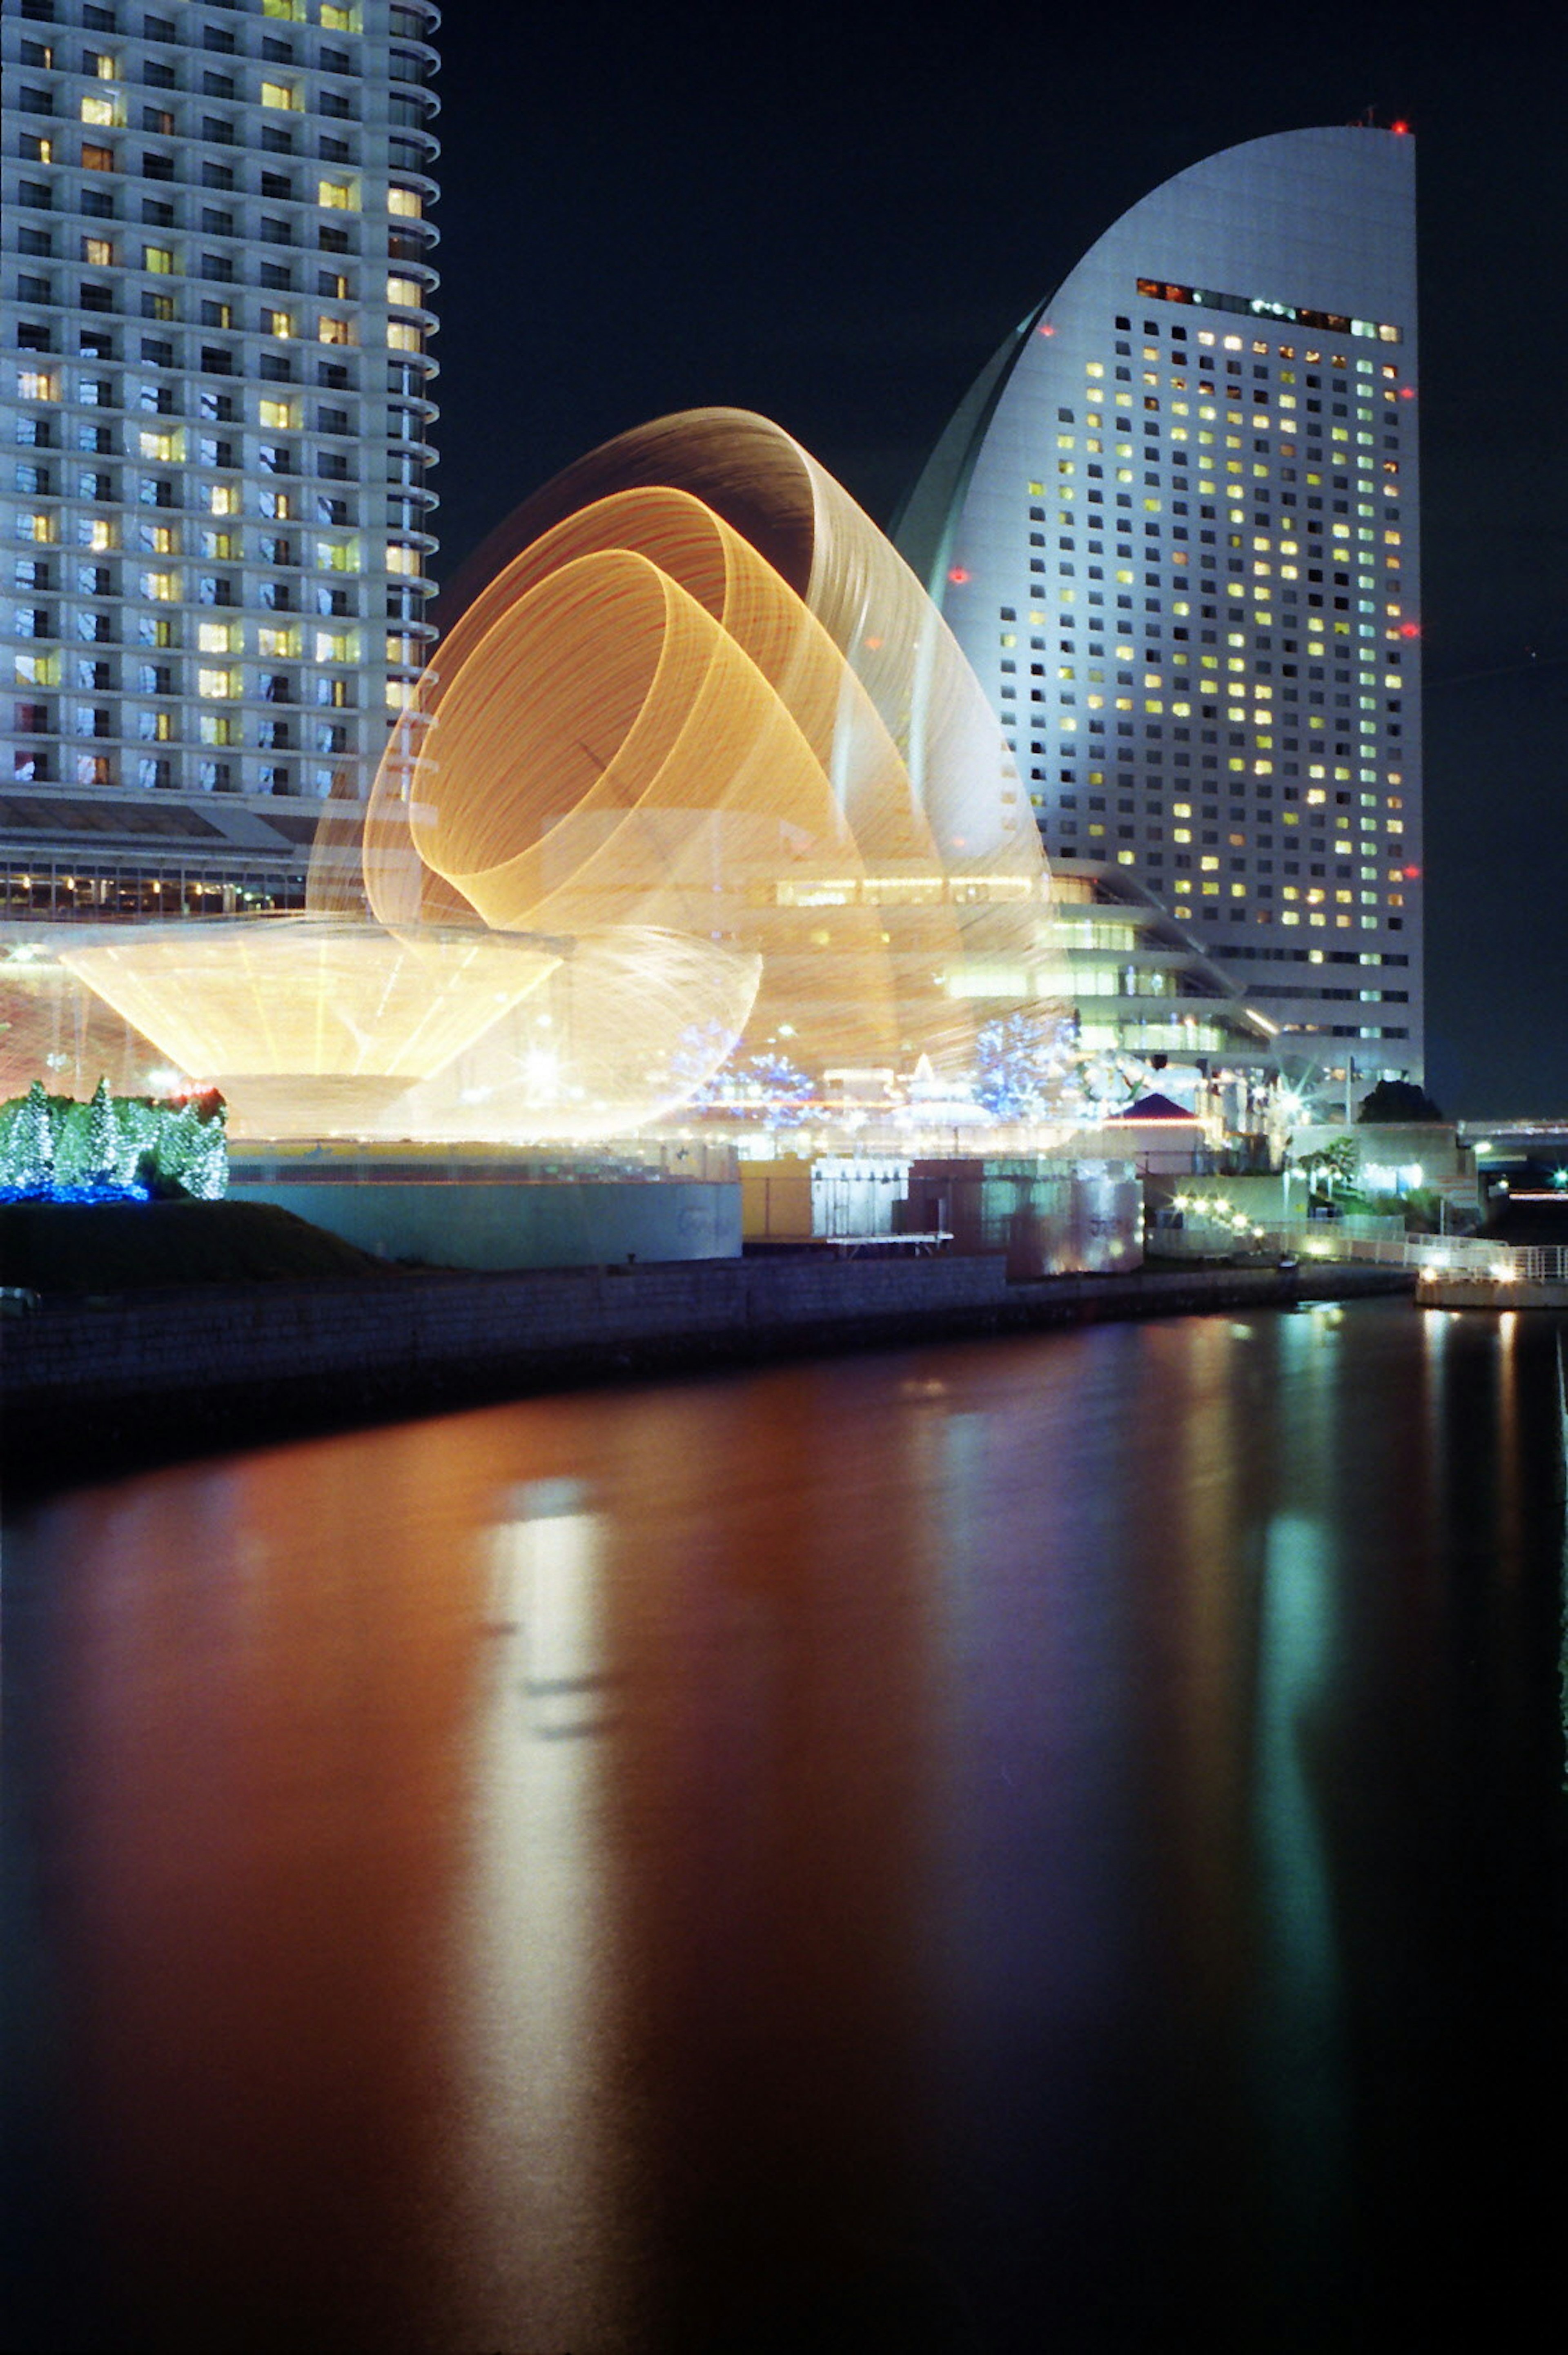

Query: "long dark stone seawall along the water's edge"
<box><xmin>0</xmin><ymin>1258</ymin><xmax>1412</xmax><ymax>1479</ymax></box>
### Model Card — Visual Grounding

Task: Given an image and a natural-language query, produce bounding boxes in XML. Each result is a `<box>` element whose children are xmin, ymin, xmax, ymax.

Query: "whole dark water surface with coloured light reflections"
<box><xmin>5</xmin><ymin>1302</ymin><xmax>1568</xmax><ymax>2355</ymax></box>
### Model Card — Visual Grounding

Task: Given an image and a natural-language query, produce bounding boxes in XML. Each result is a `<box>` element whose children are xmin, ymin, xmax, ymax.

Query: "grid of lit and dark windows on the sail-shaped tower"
<box><xmin>996</xmin><ymin>303</ymin><xmax>1417</xmax><ymax>1036</ymax></box>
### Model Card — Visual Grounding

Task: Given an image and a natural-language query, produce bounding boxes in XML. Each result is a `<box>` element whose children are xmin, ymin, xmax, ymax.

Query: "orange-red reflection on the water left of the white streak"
<box><xmin>36</xmin><ymin>1432</ymin><xmax>497</xmax><ymax>2346</ymax></box>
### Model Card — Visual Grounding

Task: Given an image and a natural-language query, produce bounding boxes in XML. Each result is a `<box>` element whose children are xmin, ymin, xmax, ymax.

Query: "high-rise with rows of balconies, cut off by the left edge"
<box><xmin>0</xmin><ymin>0</ymin><xmax>438</xmax><ymax>914</ymax></box>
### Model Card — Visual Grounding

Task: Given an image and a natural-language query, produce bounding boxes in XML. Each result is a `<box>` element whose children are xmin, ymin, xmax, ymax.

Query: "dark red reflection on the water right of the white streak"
<box><xmin>593</xmin><ymin>1368</ymin><xmax>940</xmax><ymax>2346</ymax></box>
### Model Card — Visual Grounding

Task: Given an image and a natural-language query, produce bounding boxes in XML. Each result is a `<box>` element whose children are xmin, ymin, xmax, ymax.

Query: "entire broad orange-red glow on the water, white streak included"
<box><xmin>27</xmin><ymin>1375</ymin><xmax>940</xmax><ymax>2348</ymax></box>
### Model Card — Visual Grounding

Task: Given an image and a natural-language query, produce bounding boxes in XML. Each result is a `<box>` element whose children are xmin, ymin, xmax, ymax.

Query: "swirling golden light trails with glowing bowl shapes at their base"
<box><xmin>55</xmin><ymin>410</ymin><xmax>1050</xmax><ymax>1137</ymax></box>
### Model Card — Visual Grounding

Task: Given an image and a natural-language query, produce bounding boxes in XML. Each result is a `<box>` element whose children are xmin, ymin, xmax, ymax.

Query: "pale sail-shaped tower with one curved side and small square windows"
<box><xmin>897</xmin><ymin>127</ymin><xmax>1422</xmax><ymax>1083</ymax></box>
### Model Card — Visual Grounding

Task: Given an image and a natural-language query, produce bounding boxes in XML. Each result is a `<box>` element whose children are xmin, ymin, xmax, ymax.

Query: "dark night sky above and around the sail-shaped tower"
<box><xmin>421</xmin><ymin>0</ymin><xmax>1568</xmax><ymax>1118</ymax></box>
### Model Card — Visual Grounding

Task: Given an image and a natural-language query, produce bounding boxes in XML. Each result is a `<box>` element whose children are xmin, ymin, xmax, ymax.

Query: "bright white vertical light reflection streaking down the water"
<box><xmin>454</xmin><ymin>1474</ymin><xmax>631</xmax><ymax>2348</ymax></box>
